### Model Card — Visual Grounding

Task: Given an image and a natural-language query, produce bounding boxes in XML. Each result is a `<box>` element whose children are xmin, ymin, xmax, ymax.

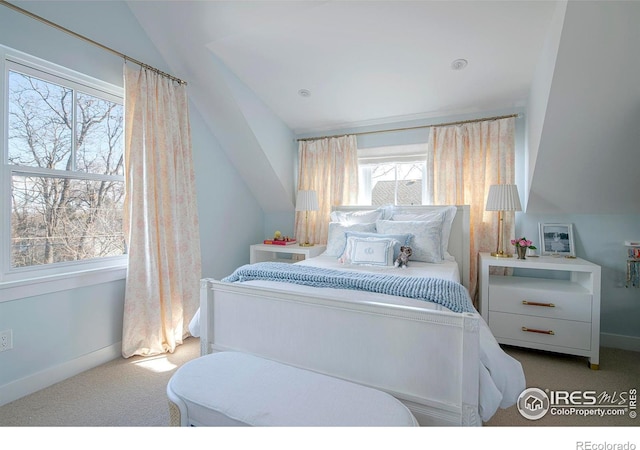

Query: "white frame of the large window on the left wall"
<box><xmin>0</xmin><ymin>45</ymin><xmax>128</xmax><ymax>284</ymax></box>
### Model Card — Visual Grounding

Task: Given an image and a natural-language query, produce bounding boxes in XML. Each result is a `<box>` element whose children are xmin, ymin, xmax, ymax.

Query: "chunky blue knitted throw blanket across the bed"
<box><xmin>222</xmin><ymin>262</ymin><xmax>476</xmax><ymax>312</ymax></box>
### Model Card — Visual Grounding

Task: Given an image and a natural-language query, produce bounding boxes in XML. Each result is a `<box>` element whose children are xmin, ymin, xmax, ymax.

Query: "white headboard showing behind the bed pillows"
<box><xmin>332</xmin><ymin>205</ymin><xmax>471</xmax><ymax>289</ymax></box>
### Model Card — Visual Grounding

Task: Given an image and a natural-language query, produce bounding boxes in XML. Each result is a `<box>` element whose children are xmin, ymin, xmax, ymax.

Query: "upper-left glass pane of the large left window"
<box><xmin>8</xmin><ymin>71</ymin><xmax>73</xmax><ymax>170</ymax></box>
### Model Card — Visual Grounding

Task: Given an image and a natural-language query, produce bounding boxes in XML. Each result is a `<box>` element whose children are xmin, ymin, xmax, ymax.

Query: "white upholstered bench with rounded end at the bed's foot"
<box><xmin>167</xmin><ymin>352</ymin><xmax>418</xmax><ymax>426</ymax></box>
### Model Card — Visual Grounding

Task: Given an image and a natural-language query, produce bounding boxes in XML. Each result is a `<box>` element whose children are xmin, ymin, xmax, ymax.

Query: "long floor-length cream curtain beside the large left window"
<box><xmin>122</xmin><ymin>64</ymin><xmax>201</xmax><ymax>358</ymax></box>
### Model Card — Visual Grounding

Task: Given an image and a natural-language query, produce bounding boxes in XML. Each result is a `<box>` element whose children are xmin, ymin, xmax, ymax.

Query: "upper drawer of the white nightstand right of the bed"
<box><xmin>489</xmin><ymin>277</ymin><xmax>592</xmax><ymax>322</ymax></box>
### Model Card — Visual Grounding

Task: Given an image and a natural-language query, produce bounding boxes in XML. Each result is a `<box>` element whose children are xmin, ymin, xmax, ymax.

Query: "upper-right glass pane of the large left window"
<box><xmin>76</xmin><ymin>92</ymin><xmax>124</xmax><ymax>175</ymax></box>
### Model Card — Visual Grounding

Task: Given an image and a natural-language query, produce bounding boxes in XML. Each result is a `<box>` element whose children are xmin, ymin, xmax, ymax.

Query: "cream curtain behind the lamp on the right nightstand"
<box><xmin>427</xmin><ymin>117</ymin><xmax>515</xmax><ymax>303</ymax></box>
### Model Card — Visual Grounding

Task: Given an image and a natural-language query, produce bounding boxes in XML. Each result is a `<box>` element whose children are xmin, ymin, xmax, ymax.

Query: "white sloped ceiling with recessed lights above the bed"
<box><xmin>127</xmin><ymin>0</ymin><xmax>640</xmax><ymax>213</ymax></box>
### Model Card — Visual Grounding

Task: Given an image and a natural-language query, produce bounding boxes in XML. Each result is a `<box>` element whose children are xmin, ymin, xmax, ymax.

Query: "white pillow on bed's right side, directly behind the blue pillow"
<box><xmin>376</xmin><ymin>219</ymin><xmax>444</xmax><ymax>263</ymax></box>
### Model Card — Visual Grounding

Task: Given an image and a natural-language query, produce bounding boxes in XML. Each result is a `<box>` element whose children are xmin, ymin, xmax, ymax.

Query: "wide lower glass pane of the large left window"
<box><xmin>11</xmin><ymin>175</ymin><xmax>125</xmax><ymax>267</ymax></box>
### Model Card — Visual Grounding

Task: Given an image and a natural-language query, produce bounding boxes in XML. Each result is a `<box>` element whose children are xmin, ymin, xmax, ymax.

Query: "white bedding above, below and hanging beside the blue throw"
<box><xmin>189</xmin><ymin>255</ymin><xmax>526</xmax><ymax>422</ymax></box>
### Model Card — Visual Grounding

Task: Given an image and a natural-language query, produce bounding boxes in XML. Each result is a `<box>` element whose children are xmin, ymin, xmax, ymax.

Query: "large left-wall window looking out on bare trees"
<box><xmin>1</xmin><ymin>49</ymin><xmax>126</xmax><ymax>279</ymax></box>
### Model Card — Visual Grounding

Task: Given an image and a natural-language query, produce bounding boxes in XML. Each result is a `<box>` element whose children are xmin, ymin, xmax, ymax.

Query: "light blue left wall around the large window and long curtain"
<box><xmin>0</xmin><ymin>1</ymin><xmax>264</xmax><ymax>404</ymax></box>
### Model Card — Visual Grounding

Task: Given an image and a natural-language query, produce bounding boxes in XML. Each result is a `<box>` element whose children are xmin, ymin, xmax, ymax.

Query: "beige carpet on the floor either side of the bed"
<box><xmin>0</xmin><ymin>338</ymin><xmax>640</xmax><ymax>428</ymax></box>
